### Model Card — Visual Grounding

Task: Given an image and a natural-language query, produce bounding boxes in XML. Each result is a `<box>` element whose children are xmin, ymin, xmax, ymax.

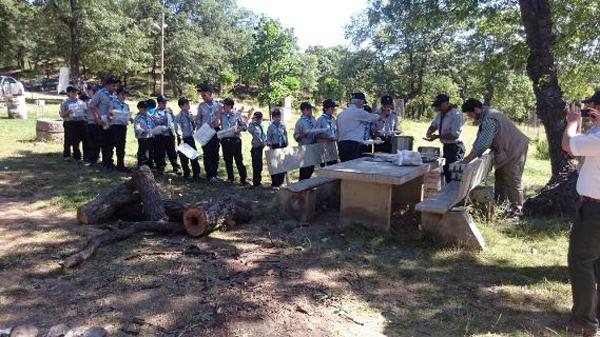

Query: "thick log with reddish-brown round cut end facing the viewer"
<box><xmin>183</xmin><ymin>195</ymin><xmax>252</xmax><ymax>237</ymax></box>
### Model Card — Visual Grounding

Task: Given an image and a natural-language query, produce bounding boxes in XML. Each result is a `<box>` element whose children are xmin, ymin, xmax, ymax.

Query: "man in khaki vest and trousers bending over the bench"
<box><xmin>462</xmin><ymin>98</ymin><xmax>529</xmax><ymax>216</ymax></box>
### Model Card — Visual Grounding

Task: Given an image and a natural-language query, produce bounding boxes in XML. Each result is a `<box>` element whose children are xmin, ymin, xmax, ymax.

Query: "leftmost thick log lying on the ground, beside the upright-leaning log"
<box><xmin>77</xmin><ymin>180</ymin><xmax>140</xmax><ymax>225</ymax></box>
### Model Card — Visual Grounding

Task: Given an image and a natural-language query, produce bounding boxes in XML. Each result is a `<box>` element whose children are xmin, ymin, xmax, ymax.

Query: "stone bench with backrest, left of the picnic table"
<box><xmin>266</xmin><ymin>142</ymin><xmax>340</xmax><ymax>222</ymax></box>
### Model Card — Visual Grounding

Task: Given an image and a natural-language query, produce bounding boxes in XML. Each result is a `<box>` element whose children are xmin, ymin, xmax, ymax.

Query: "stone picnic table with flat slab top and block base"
<box><xmin>319</xmin><ymin>157</ymin><xmax>443</xmax><ymax>231</ymax></box>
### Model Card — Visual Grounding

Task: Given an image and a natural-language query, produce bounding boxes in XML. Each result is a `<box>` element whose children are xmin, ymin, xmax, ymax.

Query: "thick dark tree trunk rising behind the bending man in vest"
<box><xmin>519</xmin><ymin>0</ymin><xmax>573</xmax><ymax>177</ymax></box>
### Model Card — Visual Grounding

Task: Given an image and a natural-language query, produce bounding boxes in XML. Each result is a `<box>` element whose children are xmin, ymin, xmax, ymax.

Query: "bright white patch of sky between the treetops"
<box><xmin>238</xmin><ymin>0</ymin><xmax>367</xmax><ymax>50</ymax></box>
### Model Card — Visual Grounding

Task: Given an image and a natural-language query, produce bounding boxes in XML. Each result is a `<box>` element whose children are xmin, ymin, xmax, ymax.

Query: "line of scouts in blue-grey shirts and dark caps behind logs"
<box><xmin>59</xmin><ymin>77</ymin><xmax>397</xmax><ymax>187</ymax></box>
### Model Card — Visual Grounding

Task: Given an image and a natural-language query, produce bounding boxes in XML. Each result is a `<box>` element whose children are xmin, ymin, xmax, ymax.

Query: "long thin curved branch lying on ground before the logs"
<box><xmin>60</xmin><ymin>221</ymin><xmax>184</xmax><ymax>268</ymax></box>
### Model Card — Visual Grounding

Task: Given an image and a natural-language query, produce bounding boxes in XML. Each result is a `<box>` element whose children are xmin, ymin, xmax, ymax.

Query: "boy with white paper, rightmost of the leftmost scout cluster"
<box><xmin>108</xmin><ymin>87</ymin><xmax>131</xmax><ymax>172</ymax></box>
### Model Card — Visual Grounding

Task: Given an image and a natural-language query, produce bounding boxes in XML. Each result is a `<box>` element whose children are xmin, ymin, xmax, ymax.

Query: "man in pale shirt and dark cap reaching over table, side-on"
<box><xmin>337</xmin><ymin>92</ymin><xmax>381</xmax><ymax>162</ymax></box>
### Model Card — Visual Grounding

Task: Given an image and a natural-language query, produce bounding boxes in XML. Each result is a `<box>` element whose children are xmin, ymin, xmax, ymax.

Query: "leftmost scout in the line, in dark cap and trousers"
<box><xmin>59</xmin><ymin>85</ymin><xmax>87</xmax><ymax>161</ymax></box>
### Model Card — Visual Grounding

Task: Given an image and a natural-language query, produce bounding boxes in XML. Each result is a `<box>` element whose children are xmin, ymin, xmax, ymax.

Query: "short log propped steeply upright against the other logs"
<box><xmin>132</xmin><ymin>165</ymin><xmax>167</xmax><ymax>221</ymax></box>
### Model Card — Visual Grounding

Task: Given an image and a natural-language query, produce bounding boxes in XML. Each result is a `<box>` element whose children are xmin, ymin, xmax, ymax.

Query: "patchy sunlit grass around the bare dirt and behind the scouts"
<box><xmin>0</xmin><ymin>92</ymin><xmax>571</xmax><ymax>336</ymax></box>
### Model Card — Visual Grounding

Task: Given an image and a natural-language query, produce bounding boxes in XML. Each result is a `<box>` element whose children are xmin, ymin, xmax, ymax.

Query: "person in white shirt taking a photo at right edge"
<box><xmin>562</xmin><ymin>91</ymin><xmax>600</xmax><ymax>336</ymax></box>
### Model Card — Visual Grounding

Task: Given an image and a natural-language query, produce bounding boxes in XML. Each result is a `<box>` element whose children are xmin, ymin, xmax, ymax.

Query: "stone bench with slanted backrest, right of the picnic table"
<box><xmin>415</xmin><ymin>154</ymin><xmax>493</xmax><ymax>250</ymax></box>
